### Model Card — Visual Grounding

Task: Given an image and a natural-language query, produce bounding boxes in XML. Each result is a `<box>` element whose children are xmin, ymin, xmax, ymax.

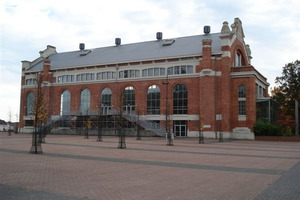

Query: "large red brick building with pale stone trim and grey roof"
<box><xmin>20</xmin><ymin>18</ymin><xmax>269</xmax><ymax>139</ymax></box>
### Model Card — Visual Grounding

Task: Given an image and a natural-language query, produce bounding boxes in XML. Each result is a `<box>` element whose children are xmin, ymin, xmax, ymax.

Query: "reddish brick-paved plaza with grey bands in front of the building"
<box><xmin>0</xmin><ymin>133</ymin><xmax>300</xmax><ymax>200</ymax></box>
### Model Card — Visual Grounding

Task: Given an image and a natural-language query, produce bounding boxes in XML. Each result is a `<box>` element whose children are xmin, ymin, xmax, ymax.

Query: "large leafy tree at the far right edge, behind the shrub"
<box><xmin>271</xmin><ymin>60</ymin><xmax>300</xmax><ymax>134</ymax></box>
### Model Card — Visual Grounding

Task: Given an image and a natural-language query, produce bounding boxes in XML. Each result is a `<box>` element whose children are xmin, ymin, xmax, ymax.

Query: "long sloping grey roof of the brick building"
<box><xmin>27</xmin><ymin>33</ymin><xmax>221</xmax><ymax>71</ymax></box>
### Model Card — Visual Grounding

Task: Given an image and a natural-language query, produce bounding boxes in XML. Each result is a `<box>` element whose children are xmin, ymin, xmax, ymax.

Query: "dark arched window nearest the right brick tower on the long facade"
<box><xmin>173</xmin><ymin>84</ymin><xmax>188</xmax><ymax>114</ymax></box>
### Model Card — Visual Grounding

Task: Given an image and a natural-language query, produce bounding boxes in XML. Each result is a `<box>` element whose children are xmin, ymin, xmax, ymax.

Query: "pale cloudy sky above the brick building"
<box><xmin>0</xmin><ymin>0</ymin><xmax>300</xmax><ymax>121</ymax></box>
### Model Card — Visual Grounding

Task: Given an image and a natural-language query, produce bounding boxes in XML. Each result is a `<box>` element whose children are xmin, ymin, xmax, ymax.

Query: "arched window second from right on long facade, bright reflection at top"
<box><xmin>147</xmin><ymin>85</ymin><xmax>160</xmax><ymax>115</ymax></box>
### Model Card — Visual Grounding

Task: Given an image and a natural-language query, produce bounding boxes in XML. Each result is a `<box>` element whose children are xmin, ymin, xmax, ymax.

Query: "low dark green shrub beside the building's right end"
<box><xmin>253</xmin><ymin>120</ymin><xmax>281</xmax><ymax>136</ymax></box>
